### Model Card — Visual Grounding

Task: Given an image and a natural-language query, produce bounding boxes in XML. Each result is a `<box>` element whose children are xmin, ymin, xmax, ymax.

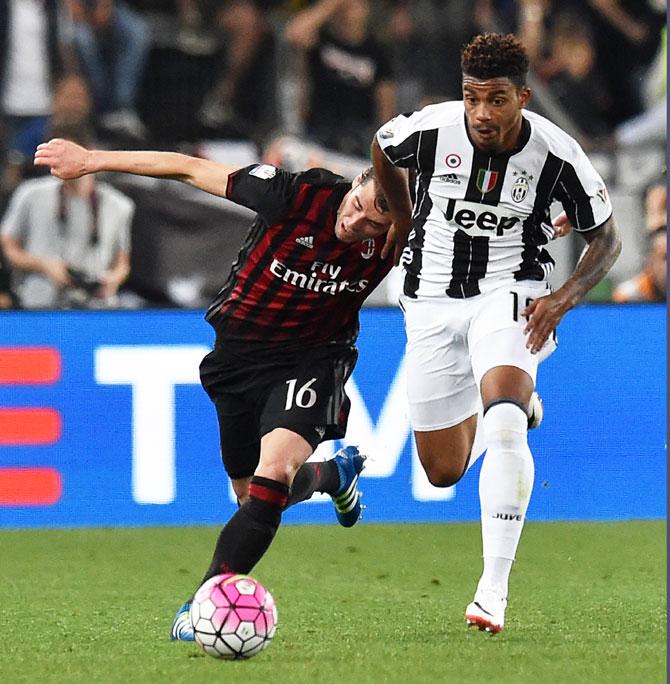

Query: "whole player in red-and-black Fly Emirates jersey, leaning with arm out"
<box><xmin>35</xmin><ymin>139</ymin><xmax>392</xmax><ymax>641</ymax></box>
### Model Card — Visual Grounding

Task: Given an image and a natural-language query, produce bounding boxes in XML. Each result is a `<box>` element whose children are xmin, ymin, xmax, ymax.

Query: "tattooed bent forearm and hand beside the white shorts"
<box><xmin>523</xmin><ymin>217</ymin><xmax>621</xmax><ymax>353</ymax></box>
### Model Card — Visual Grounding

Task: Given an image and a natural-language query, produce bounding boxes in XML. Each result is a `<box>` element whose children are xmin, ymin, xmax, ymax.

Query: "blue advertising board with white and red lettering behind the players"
<box><xmin>0</xmin><ymin>305</ymin><xmax>666</xmax><ymax>527</ymax></box>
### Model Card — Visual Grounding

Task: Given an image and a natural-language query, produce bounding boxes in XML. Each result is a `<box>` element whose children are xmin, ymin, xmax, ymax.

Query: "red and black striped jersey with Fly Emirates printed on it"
<box><xmin>206</xmin><ymin>165</ymin><xmax>392</xmax><ymax>349</ymax></box>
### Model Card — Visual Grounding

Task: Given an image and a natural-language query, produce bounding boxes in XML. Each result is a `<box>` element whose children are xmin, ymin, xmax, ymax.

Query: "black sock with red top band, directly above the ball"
<box><xmin>197</xmin><ymin>476</ymin><xmax>288</xmax><ymax>582</ymax></box>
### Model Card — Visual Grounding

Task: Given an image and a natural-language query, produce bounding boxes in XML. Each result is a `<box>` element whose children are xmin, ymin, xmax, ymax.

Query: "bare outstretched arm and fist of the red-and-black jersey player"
<box><xmin>35</xmin><ymin>138</ymin><xmax>237</xmax><ymax>197</ymax></box>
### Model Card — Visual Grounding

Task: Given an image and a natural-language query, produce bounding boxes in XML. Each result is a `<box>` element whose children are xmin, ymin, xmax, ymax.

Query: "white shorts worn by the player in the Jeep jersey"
<box><xmin>400</xmin><ymin>281</ymin><xmax>556</xmax><ymax>432</ymax></box>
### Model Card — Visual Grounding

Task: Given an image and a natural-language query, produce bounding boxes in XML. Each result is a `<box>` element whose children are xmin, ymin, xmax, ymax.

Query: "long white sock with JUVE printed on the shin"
<box><xmin>479</xmin><ymin>402</ymin><xmax>535</xmax><ymax>597</ymax></box>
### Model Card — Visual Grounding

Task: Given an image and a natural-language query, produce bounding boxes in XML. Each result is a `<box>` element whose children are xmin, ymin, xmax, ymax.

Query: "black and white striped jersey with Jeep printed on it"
<box><xmin>377</xmin><ymin>101</ymin><xmax>612</xmax><ymax>298</ymax></box>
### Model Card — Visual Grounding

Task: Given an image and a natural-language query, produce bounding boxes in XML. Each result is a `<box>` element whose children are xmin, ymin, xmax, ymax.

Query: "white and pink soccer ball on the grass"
<box><xmin>191</xmin><ymin>573</ymin><xmax>277</xmax><ymax>660</ymax></box>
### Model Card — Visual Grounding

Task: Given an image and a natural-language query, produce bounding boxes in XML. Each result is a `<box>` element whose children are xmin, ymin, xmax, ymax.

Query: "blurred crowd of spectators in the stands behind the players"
<box><xmin>0</xmin><ymin>0</ymin><xmax>667</xmax><ymax>308</ymax></box>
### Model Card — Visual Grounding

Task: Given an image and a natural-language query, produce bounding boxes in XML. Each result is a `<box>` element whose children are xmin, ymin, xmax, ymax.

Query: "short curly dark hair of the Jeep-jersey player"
<box><xmin>461</xmin><ymin>33</ymin><xmax>528</xmax><ymax>87</ymax></box>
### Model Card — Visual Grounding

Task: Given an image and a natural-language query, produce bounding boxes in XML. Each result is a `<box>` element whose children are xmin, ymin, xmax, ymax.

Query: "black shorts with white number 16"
<box><xmin>200</xmin><ymin>343</ymin><xmax>358</xmax><ymax>479</ymax></box>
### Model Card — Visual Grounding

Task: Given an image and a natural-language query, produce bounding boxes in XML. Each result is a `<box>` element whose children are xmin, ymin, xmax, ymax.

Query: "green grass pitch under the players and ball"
<box><xmin>0</xmin><ymin>521</ymin><xmax>666</xmax><ymax>684</ymax></box>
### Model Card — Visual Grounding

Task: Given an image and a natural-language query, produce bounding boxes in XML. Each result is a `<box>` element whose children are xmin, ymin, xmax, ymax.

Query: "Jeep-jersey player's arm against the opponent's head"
<box><xmin>372</xmin><ymin>138</ymin><xmax>412</xmax><ymax>266</ymax></box>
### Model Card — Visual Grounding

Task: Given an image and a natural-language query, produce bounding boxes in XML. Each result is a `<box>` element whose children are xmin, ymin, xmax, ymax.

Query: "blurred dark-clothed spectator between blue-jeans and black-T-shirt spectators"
<box><xmin>197</xmin><ymin>0</ymin><xmax>277</xmax><ymax>145</ymax></box>
